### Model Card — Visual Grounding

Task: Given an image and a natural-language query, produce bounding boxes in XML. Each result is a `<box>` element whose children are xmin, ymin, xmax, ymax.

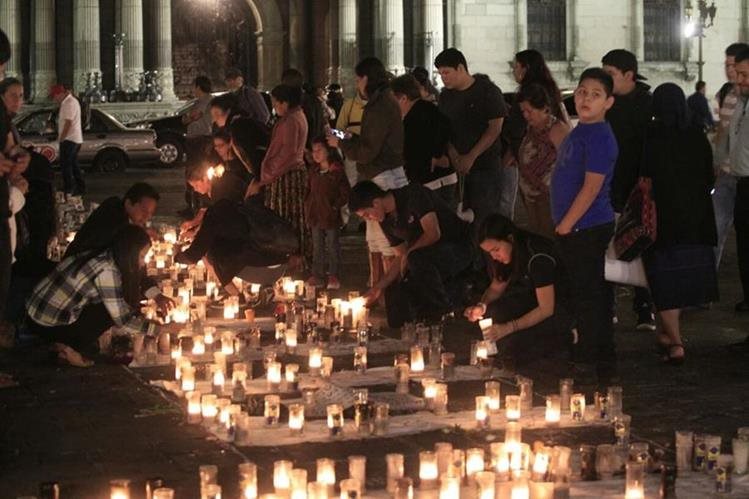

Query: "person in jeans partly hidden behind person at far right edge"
<box><xmin>713</xmin><ymin>43</ymin><xmax>749</xmax><ymax>274</ymax></box>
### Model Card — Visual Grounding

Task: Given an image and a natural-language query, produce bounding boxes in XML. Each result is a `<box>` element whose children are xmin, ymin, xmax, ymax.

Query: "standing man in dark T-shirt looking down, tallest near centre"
<box><xmin>434</xmin><ymin>48</ymin><xmax>508</xmax><ymax>228</ymax></box>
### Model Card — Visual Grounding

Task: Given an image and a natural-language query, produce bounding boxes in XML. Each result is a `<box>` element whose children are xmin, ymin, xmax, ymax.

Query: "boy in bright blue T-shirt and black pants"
<box><xmin>551</xmin><ymin>68</ymin><xmax>618</xmax><ymax>386</ymax></box>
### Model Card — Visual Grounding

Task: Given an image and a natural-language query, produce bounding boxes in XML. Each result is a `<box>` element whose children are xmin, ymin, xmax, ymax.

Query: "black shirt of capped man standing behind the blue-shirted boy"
<box><xmin>606</xmin><ymin>81</ymin><xmax>653</xmax><ymax>213</ymax></box>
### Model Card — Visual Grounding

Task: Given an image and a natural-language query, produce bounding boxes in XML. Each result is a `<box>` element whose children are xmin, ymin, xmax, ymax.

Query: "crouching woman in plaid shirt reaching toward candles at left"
<box><xmin>27</xmin><ymin>225</ymin><xmax>158</xmax><ymax>367</ymax></box>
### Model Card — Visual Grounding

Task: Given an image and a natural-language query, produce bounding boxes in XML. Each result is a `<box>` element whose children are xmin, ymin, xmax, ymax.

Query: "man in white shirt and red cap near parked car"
<box><xmin>50</xmin><ymin>84</ymin><xmax>86</xmax><ymax>195</ymax></box>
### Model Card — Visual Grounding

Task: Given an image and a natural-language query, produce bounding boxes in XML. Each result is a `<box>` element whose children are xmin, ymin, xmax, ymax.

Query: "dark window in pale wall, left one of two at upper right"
<box><xmin>528</xmin><ymin>0</ymin><xmax>567</xmax><ymax>61</ymax></box>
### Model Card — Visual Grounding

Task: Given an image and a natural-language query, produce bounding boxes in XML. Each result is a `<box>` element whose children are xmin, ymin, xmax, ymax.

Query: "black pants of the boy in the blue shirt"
<box><xmin>555</xmin><ymin>223</ymin><xmax>616</xmax><ymax>367</ymax></box>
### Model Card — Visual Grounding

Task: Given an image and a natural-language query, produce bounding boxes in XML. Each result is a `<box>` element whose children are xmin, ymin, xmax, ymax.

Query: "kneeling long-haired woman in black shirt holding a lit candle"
<box><xmin>465</xmin><ymin>214</ymin><xmax>571</xmax><ymax>367</ymax></box>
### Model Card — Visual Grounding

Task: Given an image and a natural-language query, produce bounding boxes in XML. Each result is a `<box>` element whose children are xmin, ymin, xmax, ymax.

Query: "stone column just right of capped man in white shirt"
<box><xmin>73</xmin><ymin>0</ymin><xmax>101</xmax><ymax>92</ymax></box>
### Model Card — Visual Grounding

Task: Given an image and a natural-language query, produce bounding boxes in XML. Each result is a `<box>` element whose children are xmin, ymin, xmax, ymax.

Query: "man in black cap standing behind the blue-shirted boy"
<box><xmin>601</xmin><ymin>49</ymin><xmax>655</xmax><ymax>331</ymax></box>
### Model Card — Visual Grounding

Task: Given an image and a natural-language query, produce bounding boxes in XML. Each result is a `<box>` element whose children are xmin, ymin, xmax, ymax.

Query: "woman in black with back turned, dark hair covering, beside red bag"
<box><xmin>642</xmin><ymin>83</ymin><xmax>718</xmax><ymax>364</ymax></box>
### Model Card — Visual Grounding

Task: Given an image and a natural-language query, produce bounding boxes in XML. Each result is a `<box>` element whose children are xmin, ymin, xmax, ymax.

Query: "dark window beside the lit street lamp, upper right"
<box><xmin>643</xmin><ymin>0</ymin><xmax>681</xmax><ymax>61</ymax></box>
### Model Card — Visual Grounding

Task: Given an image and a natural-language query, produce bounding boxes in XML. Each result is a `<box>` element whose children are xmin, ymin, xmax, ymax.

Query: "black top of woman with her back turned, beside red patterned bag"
<box><xmin>643</xmin><ymin>122</ymin><xmax>717</xmax><ymax>248</ymax></box>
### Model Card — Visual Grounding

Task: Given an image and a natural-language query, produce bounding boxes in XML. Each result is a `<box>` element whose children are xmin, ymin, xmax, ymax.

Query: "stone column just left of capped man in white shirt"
<box><xmin>31</xmin><ymin>0</ymin><xmax>57</xmax><ymax>102</ymax></box>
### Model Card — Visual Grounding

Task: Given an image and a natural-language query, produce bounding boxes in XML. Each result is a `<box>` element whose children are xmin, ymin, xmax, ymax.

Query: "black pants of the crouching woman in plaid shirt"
<box><xmin>28</xmin><ymin>303</ymin><xmax>114</xmax><ymax>355</ymax></box>
